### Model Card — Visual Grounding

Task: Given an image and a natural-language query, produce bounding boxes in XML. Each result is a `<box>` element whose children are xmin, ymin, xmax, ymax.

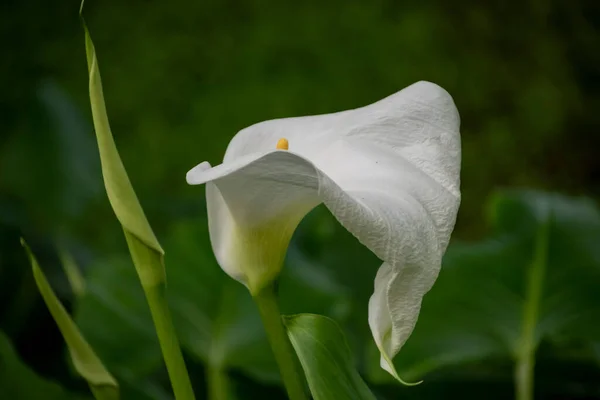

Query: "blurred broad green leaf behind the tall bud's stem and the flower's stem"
<box><xmin>75</xmin><ymin>219</ymin><xmax>348</xmax><ymax>382</ymax></box>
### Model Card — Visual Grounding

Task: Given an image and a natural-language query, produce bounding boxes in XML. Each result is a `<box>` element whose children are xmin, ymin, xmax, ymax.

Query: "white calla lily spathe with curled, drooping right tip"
<box><xmin>187</xmin><ymin>82</ymin><xmax>461</xmax><ymax>379</ymax></box>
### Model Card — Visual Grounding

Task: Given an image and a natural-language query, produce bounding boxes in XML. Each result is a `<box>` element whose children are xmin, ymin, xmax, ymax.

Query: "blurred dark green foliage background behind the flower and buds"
<box><xmin>0</xmin><ymin>0</ymin><xmax>600</xmax><ymax>400</ymax></box>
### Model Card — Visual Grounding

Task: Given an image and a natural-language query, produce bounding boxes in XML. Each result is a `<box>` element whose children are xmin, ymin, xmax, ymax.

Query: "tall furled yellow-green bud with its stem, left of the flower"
<box><xmin>79</xmin><ymin>13</ymin><xmax>194</xmax><ymax>400</ymax></box>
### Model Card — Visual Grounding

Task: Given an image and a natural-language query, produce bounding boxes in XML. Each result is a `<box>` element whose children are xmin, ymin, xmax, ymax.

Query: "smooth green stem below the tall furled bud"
<box><xmin>144</xmin><ymin>284</ymin><xmax>194</xmax><ymax>400</ymax></box>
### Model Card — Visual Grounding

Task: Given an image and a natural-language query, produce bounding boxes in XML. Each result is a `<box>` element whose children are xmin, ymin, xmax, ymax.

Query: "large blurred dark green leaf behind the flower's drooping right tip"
<box><xmin>370</xmin><ymin>192</ymin><xmax>600</xmax><ymax>380</ymax></box>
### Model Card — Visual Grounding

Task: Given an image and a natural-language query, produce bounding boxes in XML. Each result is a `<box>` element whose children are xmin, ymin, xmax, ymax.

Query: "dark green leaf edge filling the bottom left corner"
<box><xmin>0</xmin><ymin>331</ymin><xmax>83</xmax><ymax>400</ymax></box>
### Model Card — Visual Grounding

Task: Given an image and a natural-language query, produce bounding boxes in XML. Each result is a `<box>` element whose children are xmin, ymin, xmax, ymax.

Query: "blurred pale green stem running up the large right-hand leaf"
<box><xmin>515</xmin><ymin>217</ymin><xmax>550</xmax><ymax>400</ymax></box>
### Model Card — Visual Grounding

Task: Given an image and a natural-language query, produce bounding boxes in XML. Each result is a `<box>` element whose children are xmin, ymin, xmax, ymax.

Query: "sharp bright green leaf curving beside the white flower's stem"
<box><xmin>285</xmin><ymin>314</ymin><xmax>375</xmax><ymax>400</ymax></box>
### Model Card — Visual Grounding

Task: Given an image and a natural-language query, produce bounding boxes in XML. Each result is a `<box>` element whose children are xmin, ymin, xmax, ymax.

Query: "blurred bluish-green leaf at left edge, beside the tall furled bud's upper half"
<box><xmin>0</xmin><ymin>79</ymin><xmax>101</xmax><ymax>228</ymax></box>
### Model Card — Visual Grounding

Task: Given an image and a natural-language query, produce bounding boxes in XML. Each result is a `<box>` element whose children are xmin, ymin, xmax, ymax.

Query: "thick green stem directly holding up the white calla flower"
<box><xmin>254</xmin><ymin>285</ymin><xmax>308</xmax><ymax>400</ymax></box>
